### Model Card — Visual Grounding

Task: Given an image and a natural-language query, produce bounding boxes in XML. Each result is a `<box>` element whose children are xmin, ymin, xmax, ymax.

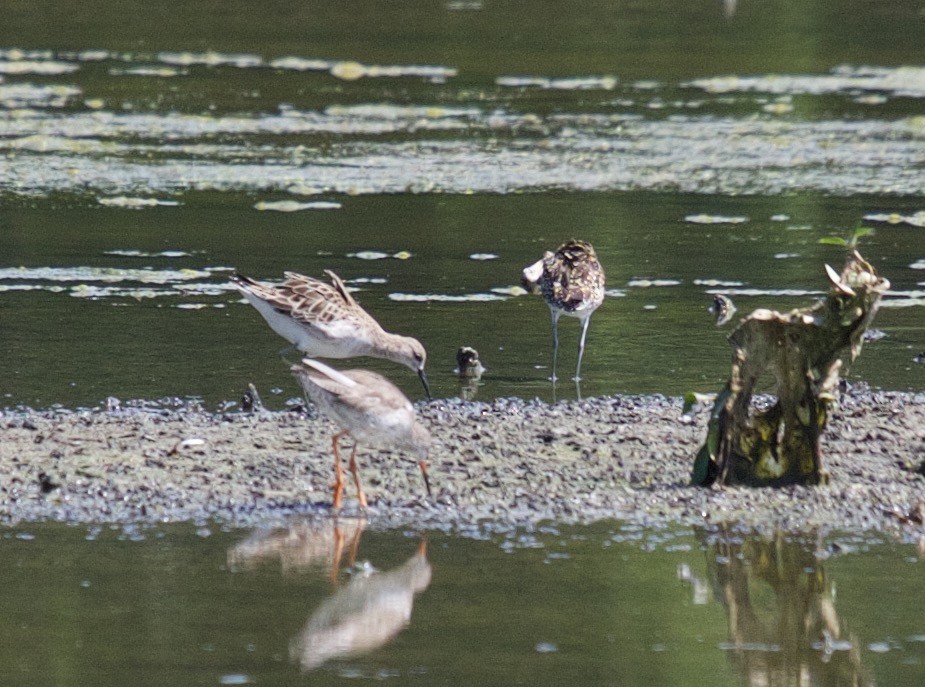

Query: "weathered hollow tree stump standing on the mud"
<box><xmin>691</xmin><ymin>250</ymin><xmax>890</xmax><ymax>486</ymax></box>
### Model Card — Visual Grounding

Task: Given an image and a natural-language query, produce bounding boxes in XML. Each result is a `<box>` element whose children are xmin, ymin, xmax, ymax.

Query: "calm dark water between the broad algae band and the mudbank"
<box><xmin>0</xmin><ymin>192</ymin><xmax>925</xmax><ymax>408</ymax></box>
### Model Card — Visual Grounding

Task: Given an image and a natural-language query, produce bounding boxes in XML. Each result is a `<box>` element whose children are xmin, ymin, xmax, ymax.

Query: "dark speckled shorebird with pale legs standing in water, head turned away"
<box><xmin>521</xmin><ymin>239</ymin><xmax>604</xmax><ymax>381</ymax></box>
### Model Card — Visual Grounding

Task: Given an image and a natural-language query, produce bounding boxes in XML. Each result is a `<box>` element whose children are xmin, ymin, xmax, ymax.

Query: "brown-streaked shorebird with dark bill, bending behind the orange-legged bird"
<box><xmin>231</xmin><ymin>270</ymin><xmax>431</xmax><ymax>400</ymax></box>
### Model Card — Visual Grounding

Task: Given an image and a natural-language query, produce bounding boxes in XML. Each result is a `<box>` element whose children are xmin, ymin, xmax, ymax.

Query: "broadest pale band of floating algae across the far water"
<box><xmin>0</xmin><ymin>113</ymin><xmax>922</xmax><ymax>198</ymax></box>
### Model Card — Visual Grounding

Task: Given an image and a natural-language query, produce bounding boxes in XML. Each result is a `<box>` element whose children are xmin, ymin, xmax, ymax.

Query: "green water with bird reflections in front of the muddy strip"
<box><xmin>0</xmin><ymin>521</ymin><xmax>925</xmax><ymax>687</ymax></box>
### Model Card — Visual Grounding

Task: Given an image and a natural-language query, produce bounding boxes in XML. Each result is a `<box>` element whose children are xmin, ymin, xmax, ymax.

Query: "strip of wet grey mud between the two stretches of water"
<box><xmin>0</xmin><ymin>390</ymin><xmax>925</xmax><ymax>536</ymax></box>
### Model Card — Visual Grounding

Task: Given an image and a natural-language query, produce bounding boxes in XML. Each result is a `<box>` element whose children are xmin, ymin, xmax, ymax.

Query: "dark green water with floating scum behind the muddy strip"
<box><xmin>0</xmin><ymin>0</ymin><xmax>925</xmax><ymax>407</ymax></box>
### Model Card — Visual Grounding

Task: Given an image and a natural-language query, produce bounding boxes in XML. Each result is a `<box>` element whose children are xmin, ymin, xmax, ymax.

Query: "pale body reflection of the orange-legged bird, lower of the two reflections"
<box><xmin>289</xmin><ymin>541</ymin><xmax>431</xmax><ymax>670</ymax></box>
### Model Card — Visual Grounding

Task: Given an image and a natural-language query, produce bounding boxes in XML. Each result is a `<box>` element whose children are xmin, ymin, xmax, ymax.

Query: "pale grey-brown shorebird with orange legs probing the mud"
<box><xmin>291</xmin><ymin>358</ymin><xmax>432</xmax><ymax>508</ymax></box>
